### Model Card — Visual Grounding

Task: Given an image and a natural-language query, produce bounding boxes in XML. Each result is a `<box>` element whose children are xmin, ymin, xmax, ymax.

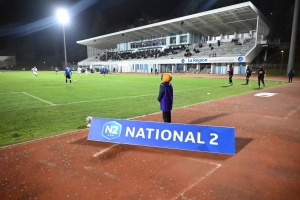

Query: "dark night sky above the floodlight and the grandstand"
<box><xmin>0</xmin><ymin>0</ymin><xmax>299</xmax><ymax>66</ymax></box>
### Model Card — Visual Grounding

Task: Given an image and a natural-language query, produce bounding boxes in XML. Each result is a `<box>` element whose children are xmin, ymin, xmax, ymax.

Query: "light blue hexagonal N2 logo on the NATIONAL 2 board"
<box><xmin>102</xmin><ymin>121</ymin><xmax>122</xmax><ymax>140</ymax></box>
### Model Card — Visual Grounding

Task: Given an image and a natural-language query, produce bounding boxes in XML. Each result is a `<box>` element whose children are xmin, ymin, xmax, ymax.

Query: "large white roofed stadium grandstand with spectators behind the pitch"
<box><xmin>77</xmin><ymin>2</ymin><xmax>276</xmax><ymax>74</ymax></box>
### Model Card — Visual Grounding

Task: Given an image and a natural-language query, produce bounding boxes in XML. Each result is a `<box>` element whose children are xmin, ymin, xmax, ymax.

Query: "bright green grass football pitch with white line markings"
<box><xmin>0</xmin><ymin>71</ymin><xmax>284</xmax><ymax>146</ymax></box>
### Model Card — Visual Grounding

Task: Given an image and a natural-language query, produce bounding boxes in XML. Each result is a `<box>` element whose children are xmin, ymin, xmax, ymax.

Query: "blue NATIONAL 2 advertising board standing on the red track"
<box><xmin>88</xmin><ymin>118</ymin><xmax>235</xmax><ymax>154</ymax></box>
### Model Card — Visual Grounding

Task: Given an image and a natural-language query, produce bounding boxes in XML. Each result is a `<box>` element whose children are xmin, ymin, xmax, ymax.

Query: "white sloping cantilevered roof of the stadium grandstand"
<box><xmin>77</xmin><ymin>2</ymin><xmax>269</xmax><ymax>49</ymax></box>
